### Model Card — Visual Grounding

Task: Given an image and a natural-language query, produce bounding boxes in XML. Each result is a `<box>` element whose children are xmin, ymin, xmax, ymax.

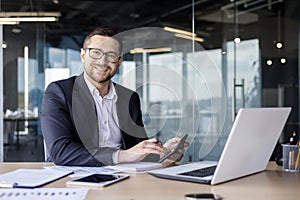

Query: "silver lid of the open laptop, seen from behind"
<box><xmin>211</xmin><ymin>108</ymin><xmax>291</xmax><ymax>185</ymax></box>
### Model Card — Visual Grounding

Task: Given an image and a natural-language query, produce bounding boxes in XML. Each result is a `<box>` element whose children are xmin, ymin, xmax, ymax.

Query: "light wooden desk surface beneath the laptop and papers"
<box><xmin>0</xmin><ymin>162</ymin><xmax>300</xmax><ymax>200</ymax></box>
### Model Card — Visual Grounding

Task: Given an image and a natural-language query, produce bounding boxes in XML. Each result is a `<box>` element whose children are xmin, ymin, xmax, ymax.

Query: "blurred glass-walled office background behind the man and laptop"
<box><xmin>0</xmin><ymin>0</ymin><xmax>300</xmax><ymax>161</ymax></box>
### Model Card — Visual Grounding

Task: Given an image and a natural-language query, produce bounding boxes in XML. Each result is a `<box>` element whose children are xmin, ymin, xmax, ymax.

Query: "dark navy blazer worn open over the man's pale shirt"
<box><xmin>41</xmin><ymin>74</ymin><xmax>147</xmax><ymax>166</ymax></box>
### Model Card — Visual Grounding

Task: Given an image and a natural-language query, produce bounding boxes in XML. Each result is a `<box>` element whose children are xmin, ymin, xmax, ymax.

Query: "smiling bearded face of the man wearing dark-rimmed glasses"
<box><xmin>81</xmin><ymin>35</ymin><xmax>122</xmax><ymax>85</ymax></box>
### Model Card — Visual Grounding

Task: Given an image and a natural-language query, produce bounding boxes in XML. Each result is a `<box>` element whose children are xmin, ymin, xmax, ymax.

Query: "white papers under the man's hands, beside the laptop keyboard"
<box><xmin>106</xmin><ymin>162</ymin><xmax>162</xmax><ymax>172</ymax></box>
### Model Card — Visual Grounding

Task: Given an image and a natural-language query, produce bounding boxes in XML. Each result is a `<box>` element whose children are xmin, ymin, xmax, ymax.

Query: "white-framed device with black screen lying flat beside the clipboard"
<box><xmin>67</xmin><ymin>174</ymin><xmax>129</xmax><ymax>188</ymax></box>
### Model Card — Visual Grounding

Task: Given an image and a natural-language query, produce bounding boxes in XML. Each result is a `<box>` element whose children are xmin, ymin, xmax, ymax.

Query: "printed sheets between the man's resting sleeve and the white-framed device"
<box><xmin>45</xmin><ymin>166</ymin><xmax>120</xmax><ymax>178</ymax></box>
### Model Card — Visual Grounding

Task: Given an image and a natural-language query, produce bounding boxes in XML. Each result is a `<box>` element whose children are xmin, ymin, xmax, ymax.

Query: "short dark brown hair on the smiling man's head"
<box><xmin>83</xmin><ymin>26</ymin><xmax>123</xmax><ymax>54</ymax></box>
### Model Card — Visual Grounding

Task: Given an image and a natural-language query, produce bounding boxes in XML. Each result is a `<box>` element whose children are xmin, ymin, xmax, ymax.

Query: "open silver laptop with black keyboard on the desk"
<box><xmin>148</xmin><ymin>107</ymin><xmax>291</xmax><ymax>185</ymax></box>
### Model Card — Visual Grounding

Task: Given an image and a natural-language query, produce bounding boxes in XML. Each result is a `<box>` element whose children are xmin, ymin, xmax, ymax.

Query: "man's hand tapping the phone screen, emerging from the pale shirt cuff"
<box><xmin>118</xmin><ymin>138</ymin><xmax>168</xmax><ymax>163</ymax></box>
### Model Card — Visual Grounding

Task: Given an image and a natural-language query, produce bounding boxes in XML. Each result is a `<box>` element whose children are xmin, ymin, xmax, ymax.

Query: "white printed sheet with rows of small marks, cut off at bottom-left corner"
<box><xmin>0</xmin><ymin>188</ymin><xmax>89</xmax><ymax>200</ymax></box>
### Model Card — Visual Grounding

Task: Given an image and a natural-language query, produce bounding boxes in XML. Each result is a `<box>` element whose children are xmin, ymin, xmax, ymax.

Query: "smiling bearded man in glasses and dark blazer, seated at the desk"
<box><xmin>41</xmin><ymin>27</ymin><xmax>182</xmax><ymax>166</ymax></box>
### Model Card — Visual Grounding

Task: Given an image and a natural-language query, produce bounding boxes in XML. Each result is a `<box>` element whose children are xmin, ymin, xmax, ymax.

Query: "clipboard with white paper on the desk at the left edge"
<box><xmin>0</xmin><ymin>169</ymin><xmax>73</xmax><ymax>188</ymax></box>
